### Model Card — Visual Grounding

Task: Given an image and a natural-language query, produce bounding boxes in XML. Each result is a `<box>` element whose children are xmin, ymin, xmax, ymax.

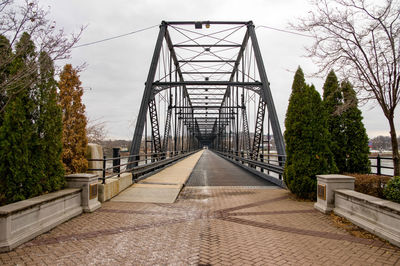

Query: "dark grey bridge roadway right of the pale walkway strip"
<box><xmin>186</xmin><ymin>150</ymin><xmax>277</xmax><ymax>188</ymax></box>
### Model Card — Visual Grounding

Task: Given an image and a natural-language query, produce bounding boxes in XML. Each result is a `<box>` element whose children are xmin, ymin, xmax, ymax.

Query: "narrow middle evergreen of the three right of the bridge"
<box><xmin>323</xmin><ymin>70</ymin><xmax>346</xmax><ymax>173</ymax></box>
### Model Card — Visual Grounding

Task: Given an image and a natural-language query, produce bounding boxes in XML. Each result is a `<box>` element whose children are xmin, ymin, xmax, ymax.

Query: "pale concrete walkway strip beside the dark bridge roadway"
<box><xmin>111</xmin><ymin>150</ymin><xmax>203</xmax><ymax>203</ymax></box>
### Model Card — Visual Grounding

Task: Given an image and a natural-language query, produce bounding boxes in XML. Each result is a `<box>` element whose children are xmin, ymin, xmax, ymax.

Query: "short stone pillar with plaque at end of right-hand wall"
<box><xmin>314</xmin><ymin>175</ymin><xmax>355</xmax><ymax>213</ymax></box>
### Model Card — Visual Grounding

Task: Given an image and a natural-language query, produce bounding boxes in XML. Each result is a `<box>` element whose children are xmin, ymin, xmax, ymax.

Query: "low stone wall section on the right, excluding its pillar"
<box><xmin>333</xmin><ymin>189</ymin><xmax>400</xmax><ymax>247</ymax></box>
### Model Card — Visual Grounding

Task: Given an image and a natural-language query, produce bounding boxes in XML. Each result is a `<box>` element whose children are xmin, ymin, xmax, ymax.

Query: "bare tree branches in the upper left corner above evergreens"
<box><xmin>0</xmin><ymin>0</ymin><xmax>84</xmax><ymax>113</ymax></box>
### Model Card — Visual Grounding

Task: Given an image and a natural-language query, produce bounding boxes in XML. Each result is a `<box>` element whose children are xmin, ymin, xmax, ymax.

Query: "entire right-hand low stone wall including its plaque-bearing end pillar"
<box><xmin>314</xmin><ymin>175</ymin><xmax>400</xmax><ymax>247</ymax></box>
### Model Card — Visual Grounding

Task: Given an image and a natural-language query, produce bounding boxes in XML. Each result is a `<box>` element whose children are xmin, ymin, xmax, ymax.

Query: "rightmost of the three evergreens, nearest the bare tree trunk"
<box><xmin>341</xmin><ymin>81</ymin><xmax>371</xmax><ymax>174</ymax></box>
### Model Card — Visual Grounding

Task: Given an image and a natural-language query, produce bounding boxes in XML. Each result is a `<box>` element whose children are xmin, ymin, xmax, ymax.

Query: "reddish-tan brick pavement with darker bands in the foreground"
<box><xmin>0</xmin><ymin>187</ymin><xmax>400</xmax><ymax>265</ymax></box>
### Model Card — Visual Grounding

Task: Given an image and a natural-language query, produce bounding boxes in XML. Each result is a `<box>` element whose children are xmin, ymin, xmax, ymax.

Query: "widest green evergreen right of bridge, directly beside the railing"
<box><xmin>284</xmin><ymin>67</ymin><xmax>337</xmax><ymax>199</ymax></box>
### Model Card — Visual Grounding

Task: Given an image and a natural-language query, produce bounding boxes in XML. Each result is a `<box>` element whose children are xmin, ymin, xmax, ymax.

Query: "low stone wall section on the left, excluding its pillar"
<box><xmin>0</xmin><ymin>188</ymin><xmax>83</xmax><ymax>252</ymax></box>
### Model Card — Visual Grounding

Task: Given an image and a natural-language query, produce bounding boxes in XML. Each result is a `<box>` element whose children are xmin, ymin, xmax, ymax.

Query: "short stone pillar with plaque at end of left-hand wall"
<box><xmin>65</xmin><ymin>174</ymin><xmax>101</xmax><ymax>212</ymax></box>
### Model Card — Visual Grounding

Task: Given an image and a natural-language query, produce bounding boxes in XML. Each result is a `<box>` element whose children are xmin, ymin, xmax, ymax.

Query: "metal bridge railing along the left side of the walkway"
<box><xmin>88</xmin><ymin>151</ymin><xmax>196</xmax><ymax>184</ymax></box>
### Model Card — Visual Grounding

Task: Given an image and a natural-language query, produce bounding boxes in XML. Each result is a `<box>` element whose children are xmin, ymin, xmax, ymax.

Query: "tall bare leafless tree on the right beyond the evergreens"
<box><xmin>291</xmin><ymin>0</ymin><xmax>400</xmax><ymax>176</ymax></box>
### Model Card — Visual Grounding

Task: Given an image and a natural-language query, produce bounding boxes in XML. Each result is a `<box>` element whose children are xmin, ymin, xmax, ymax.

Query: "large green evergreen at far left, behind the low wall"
<box><xmin>0</xmin><ymin>33</ymin><xmax>42</xmax><ymax>204</ymax></box>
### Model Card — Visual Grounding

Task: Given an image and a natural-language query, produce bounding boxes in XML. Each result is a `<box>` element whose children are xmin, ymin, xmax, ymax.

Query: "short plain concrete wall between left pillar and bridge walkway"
<box><xmin>98</xmin><ymin>173</ymin><xmax>132</xmax><ymax>202</ymax></box>
